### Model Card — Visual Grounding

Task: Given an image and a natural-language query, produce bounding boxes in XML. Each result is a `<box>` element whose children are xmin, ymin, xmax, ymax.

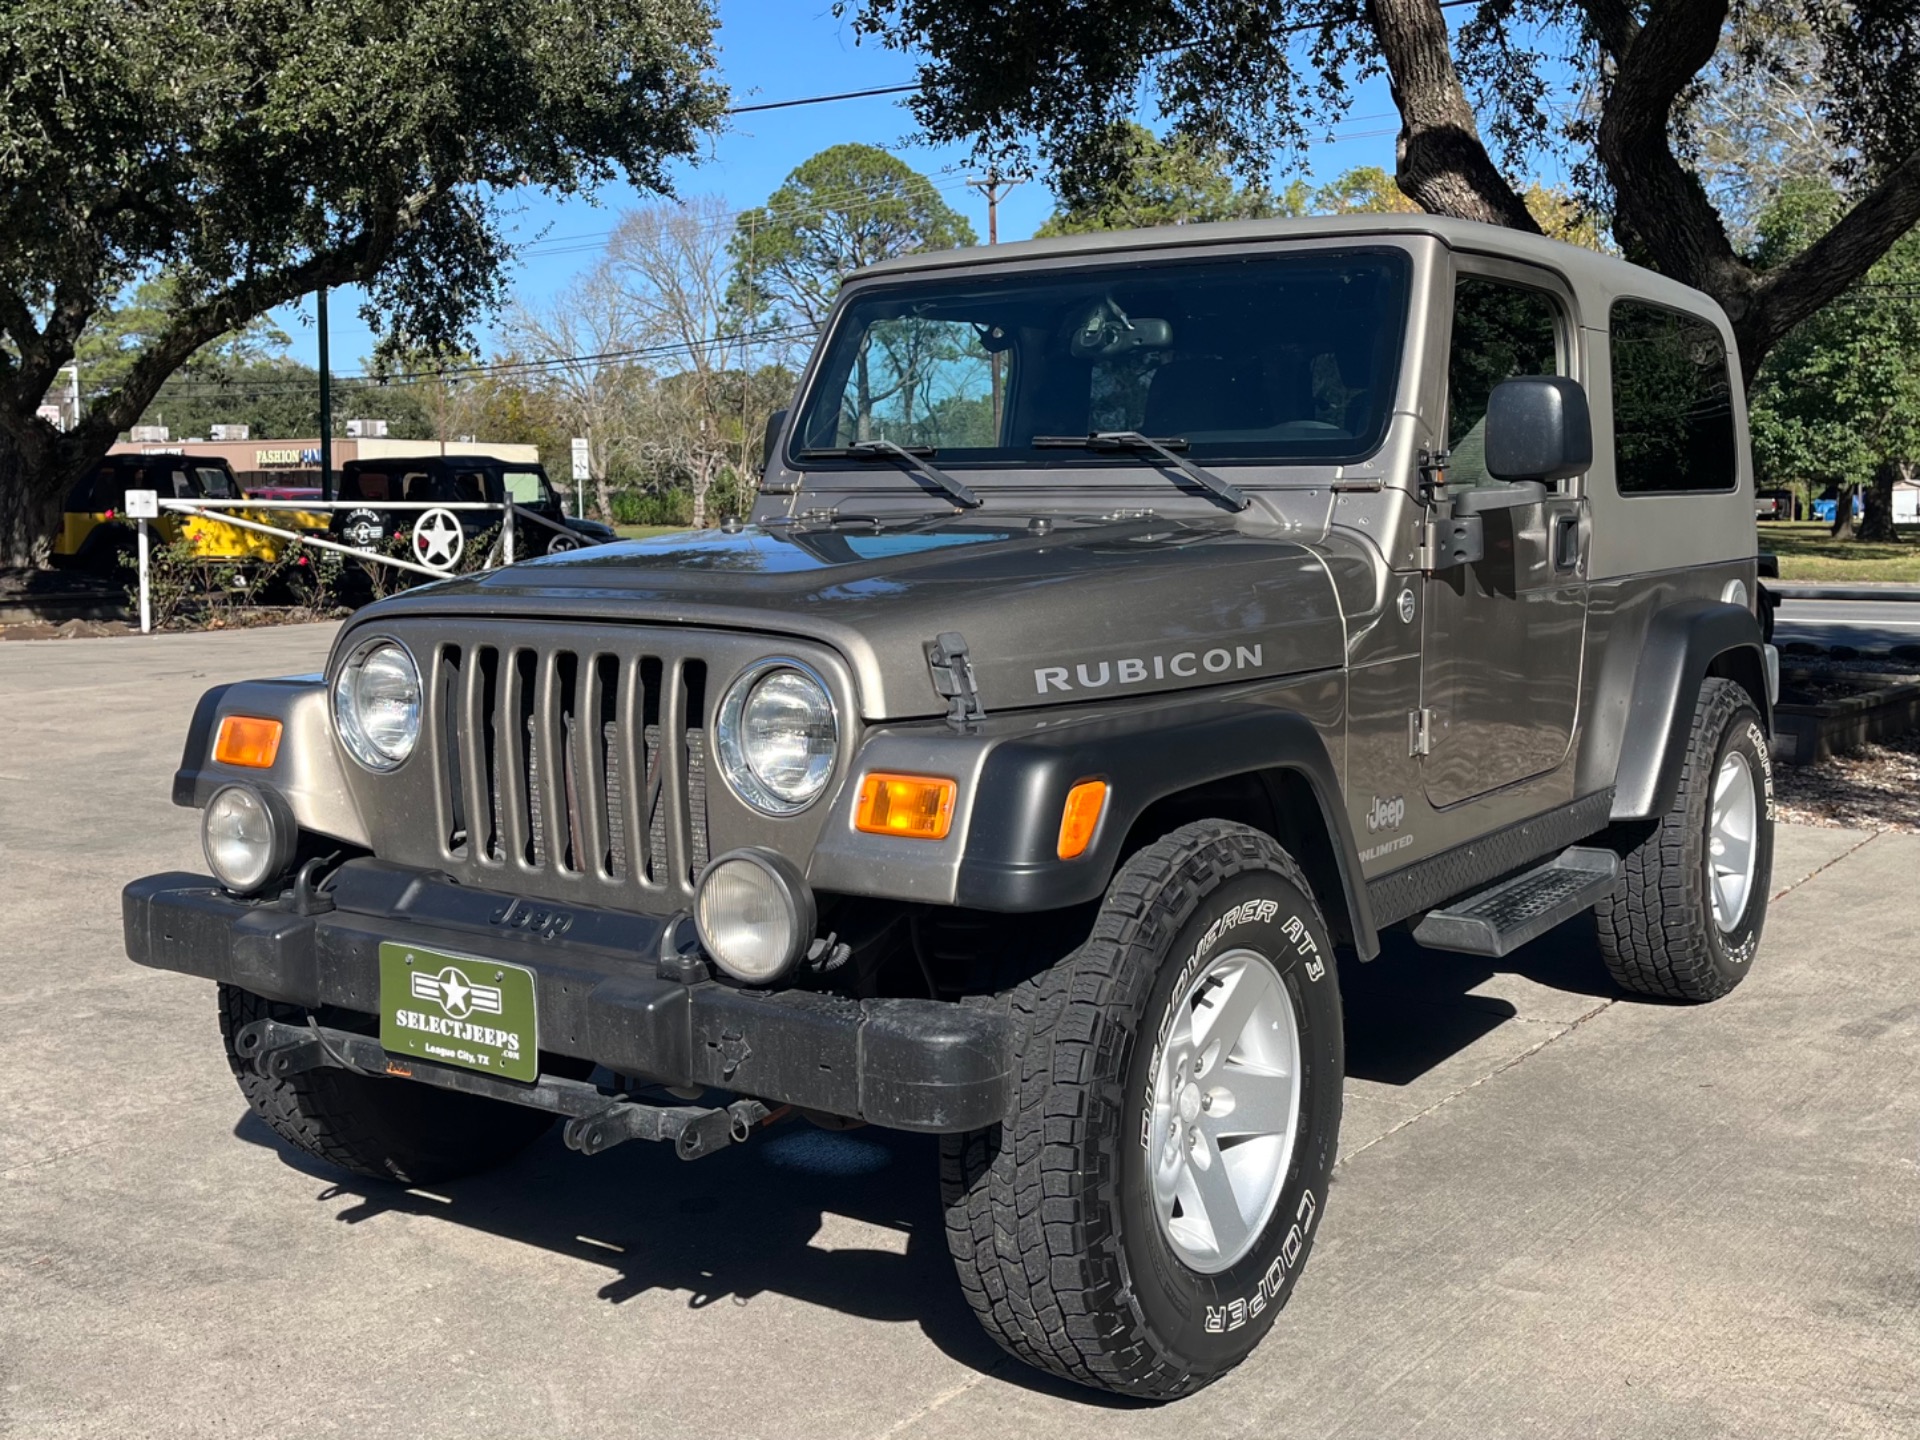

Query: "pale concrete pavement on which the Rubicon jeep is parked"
<box><xmin>0</xmin><ymin>628</ymin><xmax>1920</xmax><ymax>1440</ymax></box>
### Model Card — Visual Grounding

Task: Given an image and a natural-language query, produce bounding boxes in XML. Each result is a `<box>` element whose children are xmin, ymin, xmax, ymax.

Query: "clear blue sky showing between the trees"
<box><xmin>275</xmin><ymin>0</ymin><xmax>1396</xmax><ymax>372</ymax></box>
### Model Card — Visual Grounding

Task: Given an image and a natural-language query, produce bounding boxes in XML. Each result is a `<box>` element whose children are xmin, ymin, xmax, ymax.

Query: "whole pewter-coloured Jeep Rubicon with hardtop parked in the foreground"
<box><xmin>125</xmin><ymin>215</ymin><xmax>1776</xmax><ymax>1398</ymax></box>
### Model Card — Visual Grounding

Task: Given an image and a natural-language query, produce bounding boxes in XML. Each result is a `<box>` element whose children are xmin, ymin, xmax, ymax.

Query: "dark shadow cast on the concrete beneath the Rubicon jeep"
<box><xmin>234</xmin><ymin>924</ymin><xmax>1613</xmax><ymax>1407</ymax></box>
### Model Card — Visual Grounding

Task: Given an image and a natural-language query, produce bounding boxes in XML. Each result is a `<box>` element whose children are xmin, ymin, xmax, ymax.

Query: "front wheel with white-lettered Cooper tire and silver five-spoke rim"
<box><xmin>941</xmin><ymin>820</ymin><xmax>1344</xmax><ymax>1400</ymax></box>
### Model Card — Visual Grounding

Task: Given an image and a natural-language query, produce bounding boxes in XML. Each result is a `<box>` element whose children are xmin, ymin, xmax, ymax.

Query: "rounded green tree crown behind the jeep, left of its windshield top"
<box><xmin>730</xmin><ymin>144</ymin><xmax>975</xmax><ymax>326</ymax></box>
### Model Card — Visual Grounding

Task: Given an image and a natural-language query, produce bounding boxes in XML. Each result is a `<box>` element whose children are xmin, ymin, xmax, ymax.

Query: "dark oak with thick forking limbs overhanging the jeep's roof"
<box><xmin>856</xmin><ymin>0</ymin><xmax>1920</xmax><ymax>378</ymax></box>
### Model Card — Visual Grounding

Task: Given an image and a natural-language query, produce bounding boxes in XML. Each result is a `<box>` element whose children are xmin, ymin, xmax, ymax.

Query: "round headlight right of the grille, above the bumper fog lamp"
<box><xmin>714</xmin><ymin>660</ymin><xmax>839</xmax><ymax>814</ymax></box>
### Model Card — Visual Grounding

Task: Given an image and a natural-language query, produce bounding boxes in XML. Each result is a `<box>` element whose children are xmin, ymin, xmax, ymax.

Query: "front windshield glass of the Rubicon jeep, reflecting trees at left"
<box><xmin>789</xmin><ymin>250</ymin><xmax>1409</xmax><ymax>468</ymax></box>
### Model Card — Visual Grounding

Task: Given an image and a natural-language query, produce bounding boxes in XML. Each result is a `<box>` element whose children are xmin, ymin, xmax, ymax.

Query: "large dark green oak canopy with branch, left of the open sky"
<box><xmin>0</xmin><ymin>0</ymin><xmax>724</xmax><ymax>551</ymax></box>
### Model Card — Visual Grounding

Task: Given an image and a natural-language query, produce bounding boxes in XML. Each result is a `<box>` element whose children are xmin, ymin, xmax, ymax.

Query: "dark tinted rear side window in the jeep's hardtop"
<box><xmin>1611</xmin><ymin>300</ymin><xmax>1740</xmax><ymax>495</ymax></box>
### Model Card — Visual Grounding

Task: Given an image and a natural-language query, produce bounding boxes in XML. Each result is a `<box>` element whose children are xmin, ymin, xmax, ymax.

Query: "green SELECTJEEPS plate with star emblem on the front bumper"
<box><xmin>380</xmin><ymin>941</ymin><xmax>540</xmax><ymax>1081</ymax></box>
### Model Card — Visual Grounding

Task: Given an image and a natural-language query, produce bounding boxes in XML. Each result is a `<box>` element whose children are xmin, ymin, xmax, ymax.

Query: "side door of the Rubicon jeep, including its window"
<box><xmin>1421</xmin><ymin>257</ymin><xmax>1588</xmax><ymax>808</ymax></box>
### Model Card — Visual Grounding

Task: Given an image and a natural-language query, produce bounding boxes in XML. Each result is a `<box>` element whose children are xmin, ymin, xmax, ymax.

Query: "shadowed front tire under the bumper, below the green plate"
<box><xmin>221</xmin><ymin>985</ymin><xmax>553</xmax><ymax>1185</ymax></box>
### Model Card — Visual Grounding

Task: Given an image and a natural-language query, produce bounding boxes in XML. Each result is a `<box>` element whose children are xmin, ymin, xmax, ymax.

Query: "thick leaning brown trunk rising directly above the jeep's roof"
<box><xmin>1367</xmin><ymin>0</ymin><xmax>1540</xmax><ymax>234</ymax></box>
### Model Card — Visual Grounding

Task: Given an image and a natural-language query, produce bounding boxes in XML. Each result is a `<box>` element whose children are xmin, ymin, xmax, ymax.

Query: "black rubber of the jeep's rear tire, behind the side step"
<box><xmin>1594</xmin><ymin>678</ymin><xmax>1774</xmax><ymax>1002</ymax></box>
